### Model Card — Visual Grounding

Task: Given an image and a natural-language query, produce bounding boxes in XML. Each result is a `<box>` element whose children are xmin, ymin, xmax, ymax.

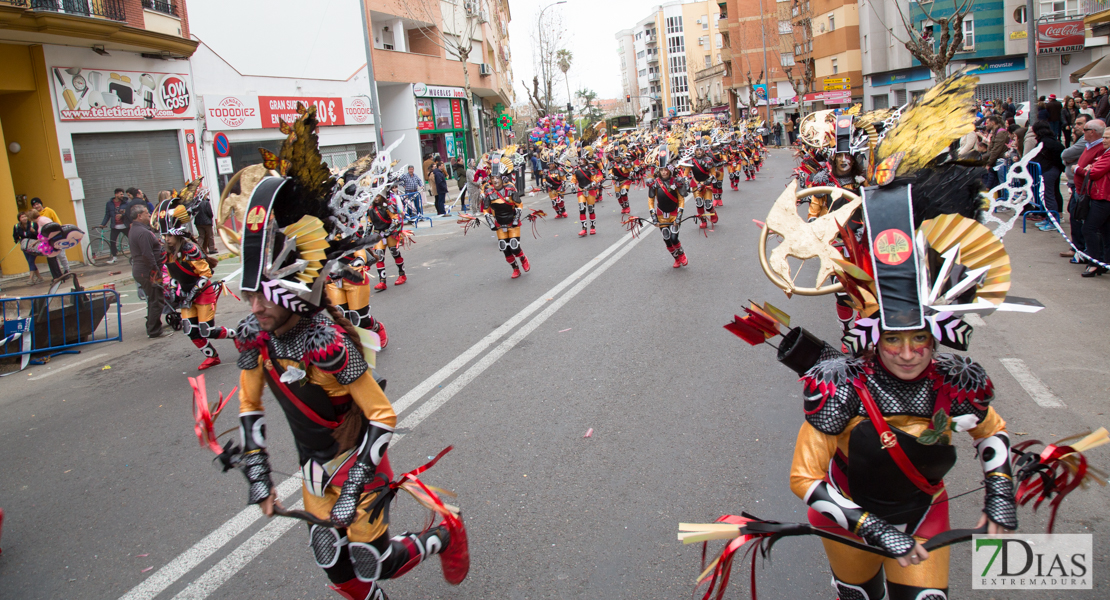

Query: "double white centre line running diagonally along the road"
<box><xmin>120</xmin><ymin>230</ymin><xmax>640</xmax><ymax>600</ymax></box>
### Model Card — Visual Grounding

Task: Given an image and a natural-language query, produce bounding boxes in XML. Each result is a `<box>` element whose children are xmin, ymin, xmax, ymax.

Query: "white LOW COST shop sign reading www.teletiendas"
<box><xmin>50</xmin><ymin>67</ymin><xmax>193</xmax><ymax>121</ymax></box>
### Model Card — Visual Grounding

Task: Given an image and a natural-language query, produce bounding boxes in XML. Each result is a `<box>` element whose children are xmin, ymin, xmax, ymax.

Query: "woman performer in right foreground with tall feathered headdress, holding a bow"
<box><xmin>680</xmin><ymin>74</ymin><xmax>1107</xmax><ymax>600</ymax></box>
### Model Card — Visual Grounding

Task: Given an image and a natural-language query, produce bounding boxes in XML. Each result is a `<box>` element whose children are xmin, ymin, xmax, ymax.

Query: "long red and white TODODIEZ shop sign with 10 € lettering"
<box><xmin>204</xmin><ymin>95</ymin><xmax>374</xmax><ymax>131</ymax></box>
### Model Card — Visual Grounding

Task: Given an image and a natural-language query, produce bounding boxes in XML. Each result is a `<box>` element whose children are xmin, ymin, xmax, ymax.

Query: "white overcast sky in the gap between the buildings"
<box><xmin>508</xmin><ymin>0</ymin><xmax>663</xmax><ymax>102</ymax></box>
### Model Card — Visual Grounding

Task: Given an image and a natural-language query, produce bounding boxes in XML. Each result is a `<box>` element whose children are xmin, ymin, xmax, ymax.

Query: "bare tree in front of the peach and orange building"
<box><xmin>397</xmin><ymin>0</ymin><xmax>484</xmax><ymax>153</ymax></box>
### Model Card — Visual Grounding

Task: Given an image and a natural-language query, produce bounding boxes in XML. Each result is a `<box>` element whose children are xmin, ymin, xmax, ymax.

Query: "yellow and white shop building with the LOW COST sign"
<box><xmin>0</xmin><ymin>0</ymin><xmax>200</xmax><ymax>275</ymax></box>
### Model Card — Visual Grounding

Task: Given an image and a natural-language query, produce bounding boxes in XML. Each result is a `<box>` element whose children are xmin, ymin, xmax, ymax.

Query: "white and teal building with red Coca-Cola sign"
<box><xmin>859</xmin><ymin>0</ymin><xmax>1110</xmax><ymax>109</ymax></box>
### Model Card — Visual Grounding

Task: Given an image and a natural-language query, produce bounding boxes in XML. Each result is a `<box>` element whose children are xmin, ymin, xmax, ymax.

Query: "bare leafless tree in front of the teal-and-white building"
<box><xmin>868</xmin><ymin>0</ymin><xmax>975</xmax><ymax>81</ymax></box>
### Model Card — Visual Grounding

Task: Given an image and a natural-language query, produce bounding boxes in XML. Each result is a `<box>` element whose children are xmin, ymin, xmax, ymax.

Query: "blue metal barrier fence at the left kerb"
<box><xmin>0</xmin><ymin>289</ymin><xmax>123</xmax><ymax>358</ymax></box>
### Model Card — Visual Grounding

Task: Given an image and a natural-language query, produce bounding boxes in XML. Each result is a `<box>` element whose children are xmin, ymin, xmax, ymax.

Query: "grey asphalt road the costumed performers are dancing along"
<box><xmin>0</xmin><ymin>151</ymin><xmax>1110</xmax><ymax>600</ymax></box>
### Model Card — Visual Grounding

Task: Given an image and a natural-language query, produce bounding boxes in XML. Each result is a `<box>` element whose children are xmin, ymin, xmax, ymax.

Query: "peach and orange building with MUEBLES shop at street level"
<box><xmin>366</xmin><ymin>0</ymin><xmax>515</xmax><ymax>170</ymax></box>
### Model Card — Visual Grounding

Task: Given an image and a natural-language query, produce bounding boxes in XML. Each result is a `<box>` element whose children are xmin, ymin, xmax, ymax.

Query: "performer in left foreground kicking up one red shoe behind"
<box><xmin>216</xmin><ymin>104</ymin><xmax>468</xmax><ymax>600</ymax></box>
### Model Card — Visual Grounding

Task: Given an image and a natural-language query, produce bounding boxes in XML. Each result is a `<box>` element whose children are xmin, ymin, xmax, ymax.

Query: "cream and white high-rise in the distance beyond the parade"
<box><xmin>615</xmin><ymin>0</ymin><xmax>725</xmax><ymax>120</ymax></box>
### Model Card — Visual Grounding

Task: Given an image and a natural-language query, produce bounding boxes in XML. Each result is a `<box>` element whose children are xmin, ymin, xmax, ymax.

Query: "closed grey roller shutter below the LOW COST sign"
<box><xmin>73</xmin><ymin>130</ymin><xmax>185</xmax><ymax>227</ymax></box>
